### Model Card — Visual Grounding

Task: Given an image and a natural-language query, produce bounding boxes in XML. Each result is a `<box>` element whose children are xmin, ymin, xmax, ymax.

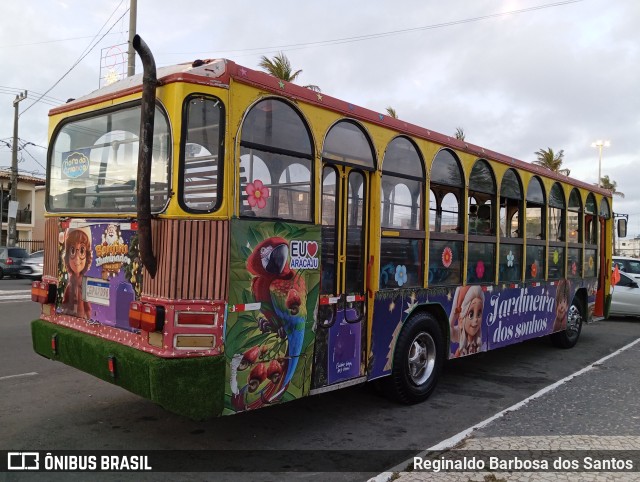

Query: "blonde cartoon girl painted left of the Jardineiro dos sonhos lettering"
<box><xmin>449</xmin><ymin>286</ymin><xmax>484</xmax><ymax>357</ymax></box>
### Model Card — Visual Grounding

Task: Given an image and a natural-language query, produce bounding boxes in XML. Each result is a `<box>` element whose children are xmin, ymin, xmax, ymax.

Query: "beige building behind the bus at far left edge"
<box><xmin>0</xmin><ymin>170</ymin><xmax>45</xmax><ymax>251</ymax></box>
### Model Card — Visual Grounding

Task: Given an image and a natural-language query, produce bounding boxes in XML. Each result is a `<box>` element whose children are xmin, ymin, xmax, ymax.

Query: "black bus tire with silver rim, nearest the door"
<box><xmin>383</xmin><ymin>313</ymin><xmax>445</xmax><ymax>405</ymax></box>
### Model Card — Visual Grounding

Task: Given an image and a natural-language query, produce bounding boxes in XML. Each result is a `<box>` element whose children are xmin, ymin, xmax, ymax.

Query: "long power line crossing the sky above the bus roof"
<box><xmin>159</xmin><ymin>0</ymin><xmax>583</xmax><ymax>55</ymax></box>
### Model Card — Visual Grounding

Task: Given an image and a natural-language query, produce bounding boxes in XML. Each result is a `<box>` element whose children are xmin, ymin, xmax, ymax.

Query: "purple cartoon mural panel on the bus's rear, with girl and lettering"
<box><xmin>56</xmin><ymin>220</ymin><xmax>142</xmax><ymax>330</ymax></box>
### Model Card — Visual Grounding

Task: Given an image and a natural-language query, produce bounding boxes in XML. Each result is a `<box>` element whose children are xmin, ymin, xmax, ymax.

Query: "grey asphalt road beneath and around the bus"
<box><xmin>0</xmin><ymin>292</ymin><xmax>640</xmax><ymax>480</ymax></box>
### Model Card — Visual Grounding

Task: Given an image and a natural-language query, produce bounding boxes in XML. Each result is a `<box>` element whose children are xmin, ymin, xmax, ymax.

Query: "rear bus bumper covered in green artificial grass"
<box><xmin>31</xmin><ymin>320</ymin><xmax>225</xmax><ymax>420</ymax></box>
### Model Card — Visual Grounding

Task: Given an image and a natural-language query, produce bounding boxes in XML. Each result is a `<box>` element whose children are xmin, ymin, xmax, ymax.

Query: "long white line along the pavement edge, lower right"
<box><xmin>368</xmin><ymin>338</ymin><xmax>640</xmax><ymax>482</ymax></box>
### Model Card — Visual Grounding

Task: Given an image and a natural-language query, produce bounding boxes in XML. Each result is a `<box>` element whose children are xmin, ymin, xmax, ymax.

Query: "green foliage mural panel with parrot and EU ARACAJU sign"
<box><xmin>225</xmin><ymin>220</ymin><xmax>320</xmax><ymax>413</ymax></box>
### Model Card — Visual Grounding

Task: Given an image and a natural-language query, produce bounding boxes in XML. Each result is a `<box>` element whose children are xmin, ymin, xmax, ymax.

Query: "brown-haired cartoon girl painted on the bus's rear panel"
<box><xmin>62</xmin><ymin>229</ymin><xmax>92</xmax><ymax>319</ymax></box>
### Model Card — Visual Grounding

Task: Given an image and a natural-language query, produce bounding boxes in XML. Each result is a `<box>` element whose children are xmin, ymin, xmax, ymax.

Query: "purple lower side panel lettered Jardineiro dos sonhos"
<box><xmin>369</xmin><ymin>279</ymin><xmax>597</xmax><ymax>380</ymax></box>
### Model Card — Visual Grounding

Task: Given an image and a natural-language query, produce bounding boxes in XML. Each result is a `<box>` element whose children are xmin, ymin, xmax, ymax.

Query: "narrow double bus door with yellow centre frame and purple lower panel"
<box><xmin>313</xmin><ymin>163</ymin><xmax>368</xmax><ymax>388</ymax></box>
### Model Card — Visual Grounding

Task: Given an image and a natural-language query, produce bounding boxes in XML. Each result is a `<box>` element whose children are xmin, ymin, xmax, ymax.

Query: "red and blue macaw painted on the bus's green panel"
<box><xmin>233</xmin><ymin>237</ymin><xmax>307</xmax><ymax>410</ymax></box>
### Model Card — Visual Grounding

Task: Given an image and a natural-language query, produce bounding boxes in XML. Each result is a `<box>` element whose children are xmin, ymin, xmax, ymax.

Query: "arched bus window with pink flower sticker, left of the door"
<box><xmin>240</xmin><ymin>99</ymin><xmax>313</xmax><ymax>221</ymax></box>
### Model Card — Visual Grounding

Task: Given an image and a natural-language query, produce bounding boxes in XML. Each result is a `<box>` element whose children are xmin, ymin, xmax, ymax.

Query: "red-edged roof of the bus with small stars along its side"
<box><xmin>49</xmin><ymin>59</ymin><xmax>612</xmax><ymax>197</ymax></box>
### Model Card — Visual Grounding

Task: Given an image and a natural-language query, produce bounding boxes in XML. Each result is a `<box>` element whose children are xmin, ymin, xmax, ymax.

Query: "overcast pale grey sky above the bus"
<box><xmin>0</xmin><ymin>0</ymin><xmax>640</xmax><ymax>235</ymax></box>
